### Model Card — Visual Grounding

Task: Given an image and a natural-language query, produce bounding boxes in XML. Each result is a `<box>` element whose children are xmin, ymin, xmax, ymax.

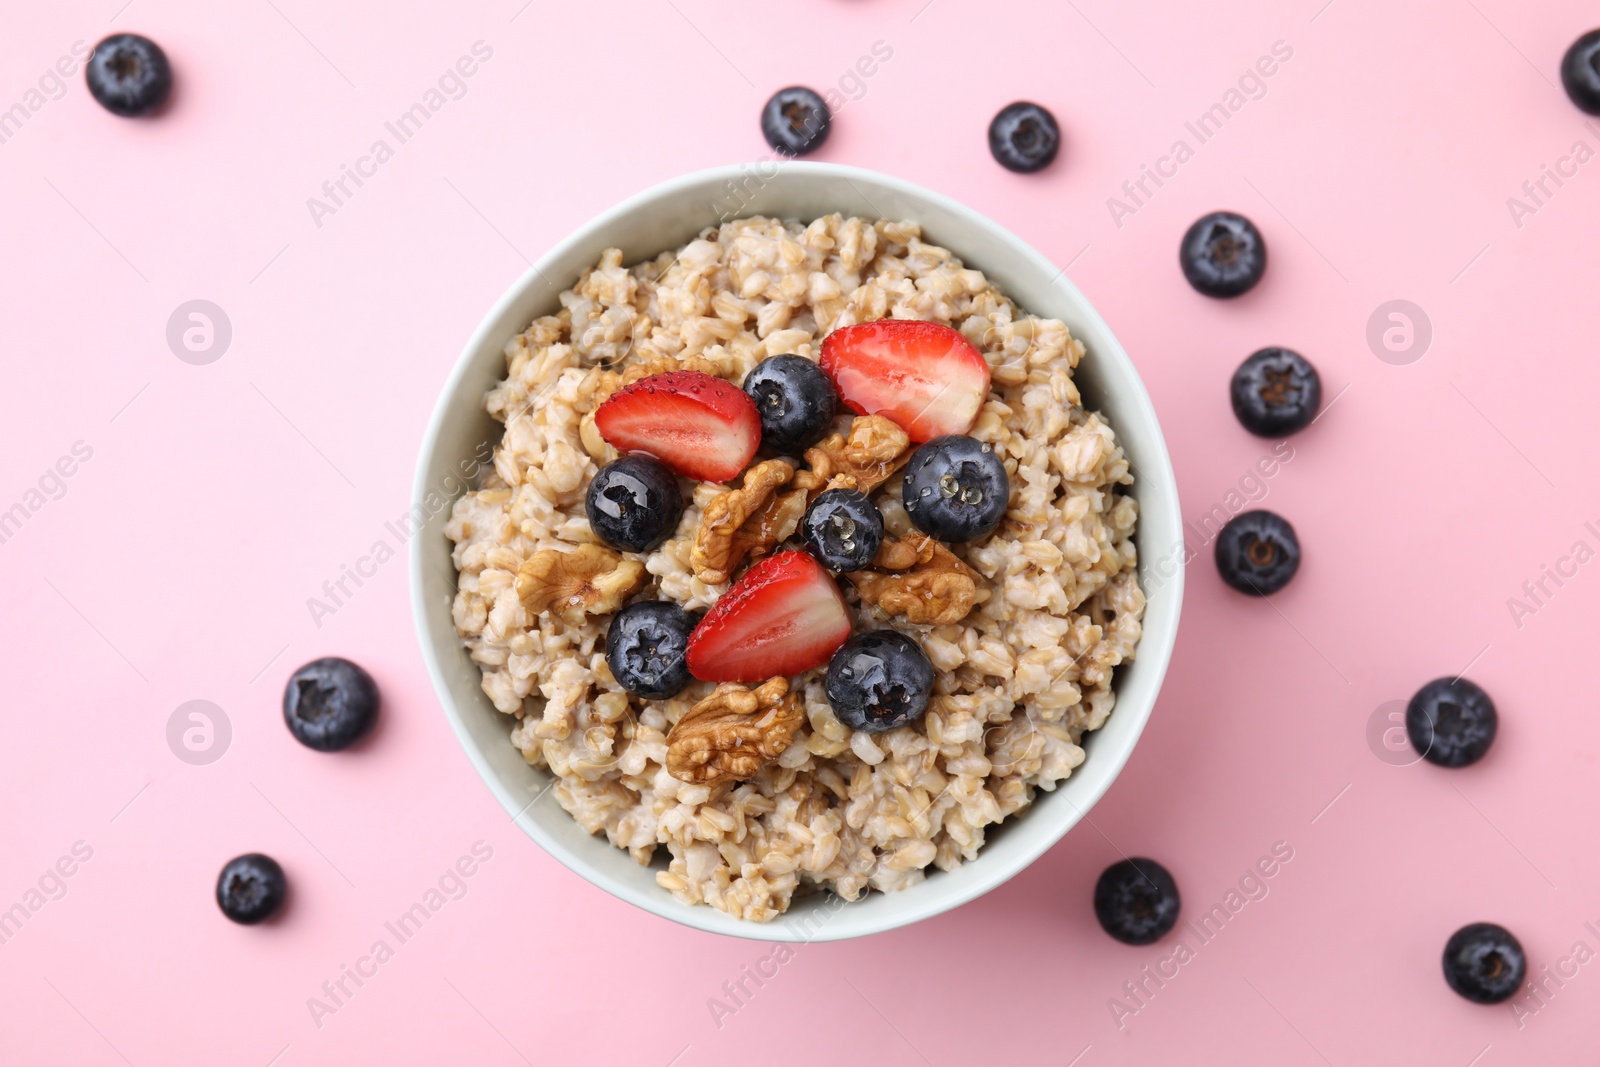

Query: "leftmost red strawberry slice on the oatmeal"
<box><xmin>595</xmin><ymin>371</ymin><xmax>762</xmax><ymax>482</ymax></box>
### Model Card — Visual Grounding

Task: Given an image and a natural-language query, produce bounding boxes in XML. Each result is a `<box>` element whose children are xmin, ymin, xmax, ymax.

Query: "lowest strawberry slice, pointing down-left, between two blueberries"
<box><xmin>688</xmin><ymin>552</ymin><xmax>850</xmax><ymax>681</ymax></box>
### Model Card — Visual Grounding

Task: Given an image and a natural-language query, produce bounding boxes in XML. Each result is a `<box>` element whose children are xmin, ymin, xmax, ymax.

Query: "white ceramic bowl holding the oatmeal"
<box><xmin>411</xmin><ymin>162</ymin><xmax>1182</xmax><ymax>941</ymax></box>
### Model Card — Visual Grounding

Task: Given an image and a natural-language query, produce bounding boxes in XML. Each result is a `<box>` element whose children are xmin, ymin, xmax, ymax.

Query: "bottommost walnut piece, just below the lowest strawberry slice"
<box><xmin>667</xmin><ymin>678</ymin><xmax>805</xmax><ymax>785</ymax></box>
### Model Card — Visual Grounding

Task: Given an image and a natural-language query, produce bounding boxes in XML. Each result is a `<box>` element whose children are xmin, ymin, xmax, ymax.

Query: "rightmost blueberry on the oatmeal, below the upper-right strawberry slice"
<box><xmin>901</xmin><ymin>434</ymin><xmax>1011</xmax><ymax>541</ymax></box>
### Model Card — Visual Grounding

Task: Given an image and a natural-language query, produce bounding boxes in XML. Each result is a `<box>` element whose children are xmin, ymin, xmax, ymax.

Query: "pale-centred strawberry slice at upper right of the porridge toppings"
<box><xmin>821</xmin><ymin>318</ymin><xmax>989</xmax><ymax>443</ymax></box>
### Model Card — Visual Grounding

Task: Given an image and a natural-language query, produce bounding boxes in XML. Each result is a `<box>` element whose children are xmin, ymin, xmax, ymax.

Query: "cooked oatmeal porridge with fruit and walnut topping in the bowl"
<box><xmin>448</xmin><ymin>214</ymin><xmax>1144</xmax><ymax>921</ymax></box>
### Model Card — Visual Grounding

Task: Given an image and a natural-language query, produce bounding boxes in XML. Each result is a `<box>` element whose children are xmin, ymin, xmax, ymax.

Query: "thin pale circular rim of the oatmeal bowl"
<box><xmin>406</xmin><ymin>160</ymin><xmax>1184</xmax><ymax>942</ymax></box>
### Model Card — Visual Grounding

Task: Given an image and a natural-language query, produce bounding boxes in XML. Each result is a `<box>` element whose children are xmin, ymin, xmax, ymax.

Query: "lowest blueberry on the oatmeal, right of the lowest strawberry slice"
<box><xmin>824</xmin><ymin>630</ymin><xmax>933</xmax><ymax>734</ymax></box>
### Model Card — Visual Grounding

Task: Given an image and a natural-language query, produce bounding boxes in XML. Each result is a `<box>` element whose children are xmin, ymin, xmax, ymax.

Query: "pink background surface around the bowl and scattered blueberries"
<box><xmin>0</xmin><ymin>0</ymin><xmax>1600</xmax><ymax>1067</ymax></box>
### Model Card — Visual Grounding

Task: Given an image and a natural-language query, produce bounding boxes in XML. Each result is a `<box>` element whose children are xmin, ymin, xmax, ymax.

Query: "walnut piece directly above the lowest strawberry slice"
<box><xmin>690</xmin><ymin>459</ymin><xmax>806</xmax><ymax>585</ymax></box>
